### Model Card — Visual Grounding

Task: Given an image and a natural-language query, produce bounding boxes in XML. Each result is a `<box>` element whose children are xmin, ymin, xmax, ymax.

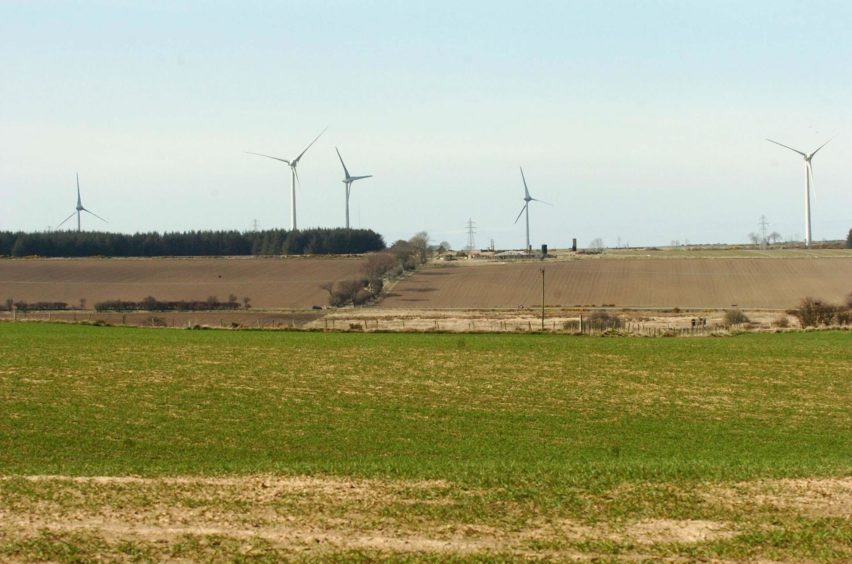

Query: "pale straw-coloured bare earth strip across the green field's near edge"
<box><xmin>0</xmin><ymin>475</ymin><xmax>852</xmax><ymax>559</ymax></box>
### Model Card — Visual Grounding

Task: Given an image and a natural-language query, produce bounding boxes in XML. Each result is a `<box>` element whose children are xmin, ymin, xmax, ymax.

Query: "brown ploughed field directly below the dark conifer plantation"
<box><xmin>0</xmin><ymin>257</ymin><xmax>362</xmax><ymax>309</ymax></box>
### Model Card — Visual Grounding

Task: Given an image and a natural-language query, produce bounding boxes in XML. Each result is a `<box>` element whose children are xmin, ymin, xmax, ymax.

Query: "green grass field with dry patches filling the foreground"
<box><xmin>0</xmin><ymin>323</ymin><xmax>852</xmax><ymax>561</ymax></box>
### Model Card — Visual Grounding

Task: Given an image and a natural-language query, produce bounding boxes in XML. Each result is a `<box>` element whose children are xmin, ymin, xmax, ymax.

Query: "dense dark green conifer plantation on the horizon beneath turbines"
<box><xmin>0</xmin><ymin>228</ymin><xmax>385</xmax><ymax>257</ymax></box>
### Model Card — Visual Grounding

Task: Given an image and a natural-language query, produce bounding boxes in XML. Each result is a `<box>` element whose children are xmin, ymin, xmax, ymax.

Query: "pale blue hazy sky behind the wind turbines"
<box><xmin>0</xmin><ymin>0</ymin><xmax>852</xmax><ymax>248</ymax></box>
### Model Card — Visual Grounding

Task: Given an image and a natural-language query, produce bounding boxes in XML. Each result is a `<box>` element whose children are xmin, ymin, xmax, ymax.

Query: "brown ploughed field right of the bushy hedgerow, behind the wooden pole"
<box><xmin>380</xmin><ymin>255</ymin><xmax>852</xmax><ymax>309</ymax></box>
